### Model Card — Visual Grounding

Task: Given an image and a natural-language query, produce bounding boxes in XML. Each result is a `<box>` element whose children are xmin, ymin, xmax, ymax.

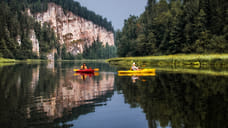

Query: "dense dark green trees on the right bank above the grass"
<box><xmin>116</xmin><ymin>0</ymin><xmax>228</xmax><ymax>56</ymax></box>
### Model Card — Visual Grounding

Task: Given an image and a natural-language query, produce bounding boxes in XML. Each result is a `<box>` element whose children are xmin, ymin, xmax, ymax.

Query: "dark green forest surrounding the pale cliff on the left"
<box><xmin>0</xmin><ymin>0</ymin><xmax>114</xmax><ymax>59</ymax></box>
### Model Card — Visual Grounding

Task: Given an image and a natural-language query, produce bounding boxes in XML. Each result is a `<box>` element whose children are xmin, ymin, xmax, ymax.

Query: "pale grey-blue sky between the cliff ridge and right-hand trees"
<box><xmin>75</xmin><ymin>0</ymin><xmax>147</xmax><ymax>30</ymax></box>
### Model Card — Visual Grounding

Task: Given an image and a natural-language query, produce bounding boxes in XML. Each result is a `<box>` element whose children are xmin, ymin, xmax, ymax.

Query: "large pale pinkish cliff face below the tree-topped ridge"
<box><xmin>32</xmin><ymin>3</ymin><xmax>114</xmax><ymax>55</ymax></box>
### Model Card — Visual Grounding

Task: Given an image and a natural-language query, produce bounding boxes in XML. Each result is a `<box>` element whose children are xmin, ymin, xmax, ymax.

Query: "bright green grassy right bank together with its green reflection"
<box><xmin>106</xmin><ymin>54</ymin><xmax>228</xmax><ymax>76</ymax></box>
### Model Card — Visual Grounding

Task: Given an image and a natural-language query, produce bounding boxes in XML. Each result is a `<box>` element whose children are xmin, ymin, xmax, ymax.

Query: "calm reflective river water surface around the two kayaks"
<box><xmin>0</xmin><ymin>62</ymin><xmax>228</xmax><ymax>128</ymax></box>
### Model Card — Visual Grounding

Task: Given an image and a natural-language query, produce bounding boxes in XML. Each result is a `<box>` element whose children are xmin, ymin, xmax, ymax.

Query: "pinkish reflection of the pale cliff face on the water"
<box><xmin>31</xmin><ymin>73</ymin><xmax>114</xmax><ymax>119</ymax></box>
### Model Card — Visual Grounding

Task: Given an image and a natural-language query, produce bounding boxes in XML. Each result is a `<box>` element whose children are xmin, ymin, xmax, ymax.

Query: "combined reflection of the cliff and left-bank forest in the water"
<box><xmin>0</xmin><ymin>63</ymin><xmax>114</xmax><ymax>128</ymax></box>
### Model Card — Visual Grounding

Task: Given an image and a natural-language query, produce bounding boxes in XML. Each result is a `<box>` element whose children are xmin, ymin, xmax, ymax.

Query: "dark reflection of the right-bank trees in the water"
<box><xmin>117</xmin><ymin>73</ymin><xmax>228</xmax><ymax>128</ymax></box>
